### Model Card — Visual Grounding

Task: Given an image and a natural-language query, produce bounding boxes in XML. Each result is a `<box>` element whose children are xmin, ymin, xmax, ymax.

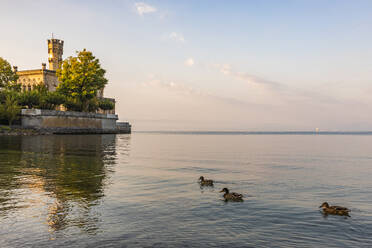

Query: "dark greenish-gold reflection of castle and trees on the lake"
<box><xmin>0</xmin><ymin>135</ymin><xmax>126</xmax><ymax>233</ymax></box>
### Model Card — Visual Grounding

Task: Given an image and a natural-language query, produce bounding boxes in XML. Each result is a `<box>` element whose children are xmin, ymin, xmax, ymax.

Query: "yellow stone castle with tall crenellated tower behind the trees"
<box><xmin>13</xmin><ymin>38</ymin><xmax>115</xmax><ymax>114</ymax></box>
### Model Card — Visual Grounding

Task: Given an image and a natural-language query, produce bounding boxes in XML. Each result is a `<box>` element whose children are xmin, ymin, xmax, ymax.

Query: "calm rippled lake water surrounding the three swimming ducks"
<box><xmin>0</xmin><ymin>133</ymin><xmax>372</xmax><ymax>247</ymax></box>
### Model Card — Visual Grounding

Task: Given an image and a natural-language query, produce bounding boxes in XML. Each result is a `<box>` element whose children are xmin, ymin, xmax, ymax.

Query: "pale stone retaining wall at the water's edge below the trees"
<box><xmin>21</xmin><ymin>109</ymin><xmax>122</xmax><ymax>133</ymax></box>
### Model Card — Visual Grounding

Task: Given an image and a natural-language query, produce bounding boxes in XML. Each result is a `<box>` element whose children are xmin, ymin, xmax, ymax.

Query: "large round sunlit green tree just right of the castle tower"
<box><xmin>57</xmin><ymin>49</ymin><xmax>107</xmax><ymax>112</ymax></box>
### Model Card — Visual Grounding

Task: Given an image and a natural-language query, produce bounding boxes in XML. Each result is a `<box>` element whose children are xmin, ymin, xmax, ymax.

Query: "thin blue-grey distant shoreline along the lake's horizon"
<box><xmin>134</xmin><ymin>131</ymin><xmax>372</xmax><ymax>135</ymax></box>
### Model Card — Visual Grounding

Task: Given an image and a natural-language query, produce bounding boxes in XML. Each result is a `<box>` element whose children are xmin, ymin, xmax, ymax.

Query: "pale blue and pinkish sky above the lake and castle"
<box><xmin>0</xmin><ymin>0</ymin><xmax>372</xmax><ymax>131</ymax></box>
